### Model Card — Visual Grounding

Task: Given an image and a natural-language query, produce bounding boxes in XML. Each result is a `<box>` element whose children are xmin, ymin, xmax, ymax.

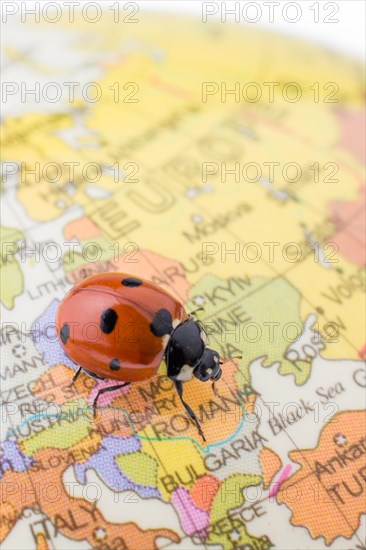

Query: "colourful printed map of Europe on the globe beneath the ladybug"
<box><xmin>0</xmin><ymin>2</ymin><xmax>366</xmax><ymax>550</ymax></box>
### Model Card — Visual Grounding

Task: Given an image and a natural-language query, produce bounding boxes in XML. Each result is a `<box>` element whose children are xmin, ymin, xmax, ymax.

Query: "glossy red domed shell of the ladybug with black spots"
<box><xmin>56</xmin><ymin>273</ymin><xmax>187</xmax><ymax>382</ymax></box>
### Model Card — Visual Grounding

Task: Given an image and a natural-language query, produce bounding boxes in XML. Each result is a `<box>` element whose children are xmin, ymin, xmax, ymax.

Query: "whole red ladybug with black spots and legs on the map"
<box><xmin>56</xmin><ymin>272</ymin><xmax>240</xmax><ymax>441</ymax></box>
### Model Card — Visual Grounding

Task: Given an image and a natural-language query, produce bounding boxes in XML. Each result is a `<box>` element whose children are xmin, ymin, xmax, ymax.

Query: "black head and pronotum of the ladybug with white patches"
<box><xmin>165</xmin><ymin>318</ymin><xmax>222</xmax><ymax>382</ymax></box>
